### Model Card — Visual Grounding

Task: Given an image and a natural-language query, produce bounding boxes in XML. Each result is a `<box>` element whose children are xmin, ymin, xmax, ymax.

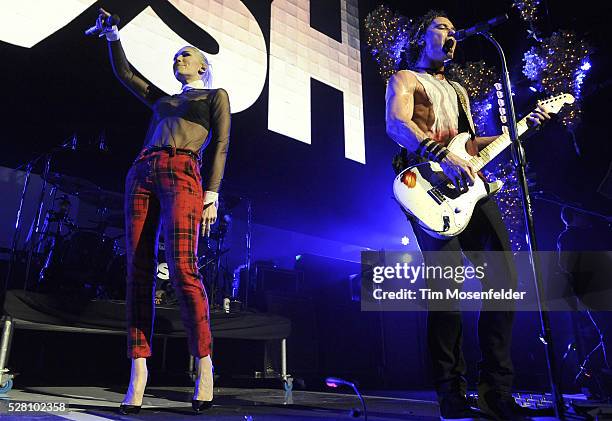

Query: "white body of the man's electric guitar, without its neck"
<box><xmin>393</xmin><ymin>133</ymin><xmax>498</xmax><ymax>239</ymax></box>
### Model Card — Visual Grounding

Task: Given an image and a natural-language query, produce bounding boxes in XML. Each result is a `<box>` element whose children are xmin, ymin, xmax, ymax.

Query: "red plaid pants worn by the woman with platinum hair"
<box><xmin>125</xmin><ymin>151</ymin><xmax>211</xmax><ymax>358</ymax></box>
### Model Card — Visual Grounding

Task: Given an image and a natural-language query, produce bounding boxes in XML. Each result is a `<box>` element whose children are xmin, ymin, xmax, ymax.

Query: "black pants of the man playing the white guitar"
<box><xmin>411</xmin><ymin>198</ymin><xmax>517</xmax><ymax>393</ymax></box>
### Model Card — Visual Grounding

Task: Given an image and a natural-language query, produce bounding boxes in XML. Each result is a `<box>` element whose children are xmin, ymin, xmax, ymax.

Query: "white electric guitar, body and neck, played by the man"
<box><xmin>393</xmin><ymin>94</ymin><xmax>574</xmax><ymax>238</ymax></box>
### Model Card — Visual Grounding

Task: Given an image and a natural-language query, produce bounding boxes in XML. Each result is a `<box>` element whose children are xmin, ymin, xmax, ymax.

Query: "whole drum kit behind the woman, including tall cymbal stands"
<box><xmin>0</xmin><ymin>134</ymin><xmax>252</xmax><ymax>306</ymax></box>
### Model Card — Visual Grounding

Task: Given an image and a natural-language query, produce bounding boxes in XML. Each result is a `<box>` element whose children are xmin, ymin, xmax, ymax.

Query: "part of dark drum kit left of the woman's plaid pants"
<box><xmin>33</xmin><ymin>173</ymin><xmax>125</xmax><ymax>298</ymax></box>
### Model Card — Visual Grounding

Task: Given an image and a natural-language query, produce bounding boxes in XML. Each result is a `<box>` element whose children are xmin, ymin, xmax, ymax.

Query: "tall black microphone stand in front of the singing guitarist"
<box><xmin>479</xmin><ymin>31</ymin><xmax>565</xmax><ymax>419</ymax></box>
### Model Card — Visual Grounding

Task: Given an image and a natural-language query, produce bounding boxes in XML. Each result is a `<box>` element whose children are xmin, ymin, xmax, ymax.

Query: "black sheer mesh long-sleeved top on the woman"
<box><xmin>109</xmin><ymin>41</ymin><xmax>231</xmax><ymax>192</ymax></box>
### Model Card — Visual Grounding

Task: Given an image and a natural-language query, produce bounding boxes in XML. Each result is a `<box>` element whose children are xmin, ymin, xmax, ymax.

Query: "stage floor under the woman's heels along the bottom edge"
<box><xmin>0</xmin><ymin>387</ymin><xmax>572</xmax><ymax>421</ymax></box>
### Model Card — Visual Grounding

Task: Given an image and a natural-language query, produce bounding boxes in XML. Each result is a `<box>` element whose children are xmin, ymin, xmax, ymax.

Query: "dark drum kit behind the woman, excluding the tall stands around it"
<box><xmin>26</xmin><ymin>173</ymin><xmax>241</xmax><ymax>306</ymax></box>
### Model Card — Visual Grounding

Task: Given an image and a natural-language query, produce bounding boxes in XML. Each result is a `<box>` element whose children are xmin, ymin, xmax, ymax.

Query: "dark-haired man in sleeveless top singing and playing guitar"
<box><xmin>386</xmin><ymin>11</ymin><xmax>550</xmax><ymax>420</ymax></box>
